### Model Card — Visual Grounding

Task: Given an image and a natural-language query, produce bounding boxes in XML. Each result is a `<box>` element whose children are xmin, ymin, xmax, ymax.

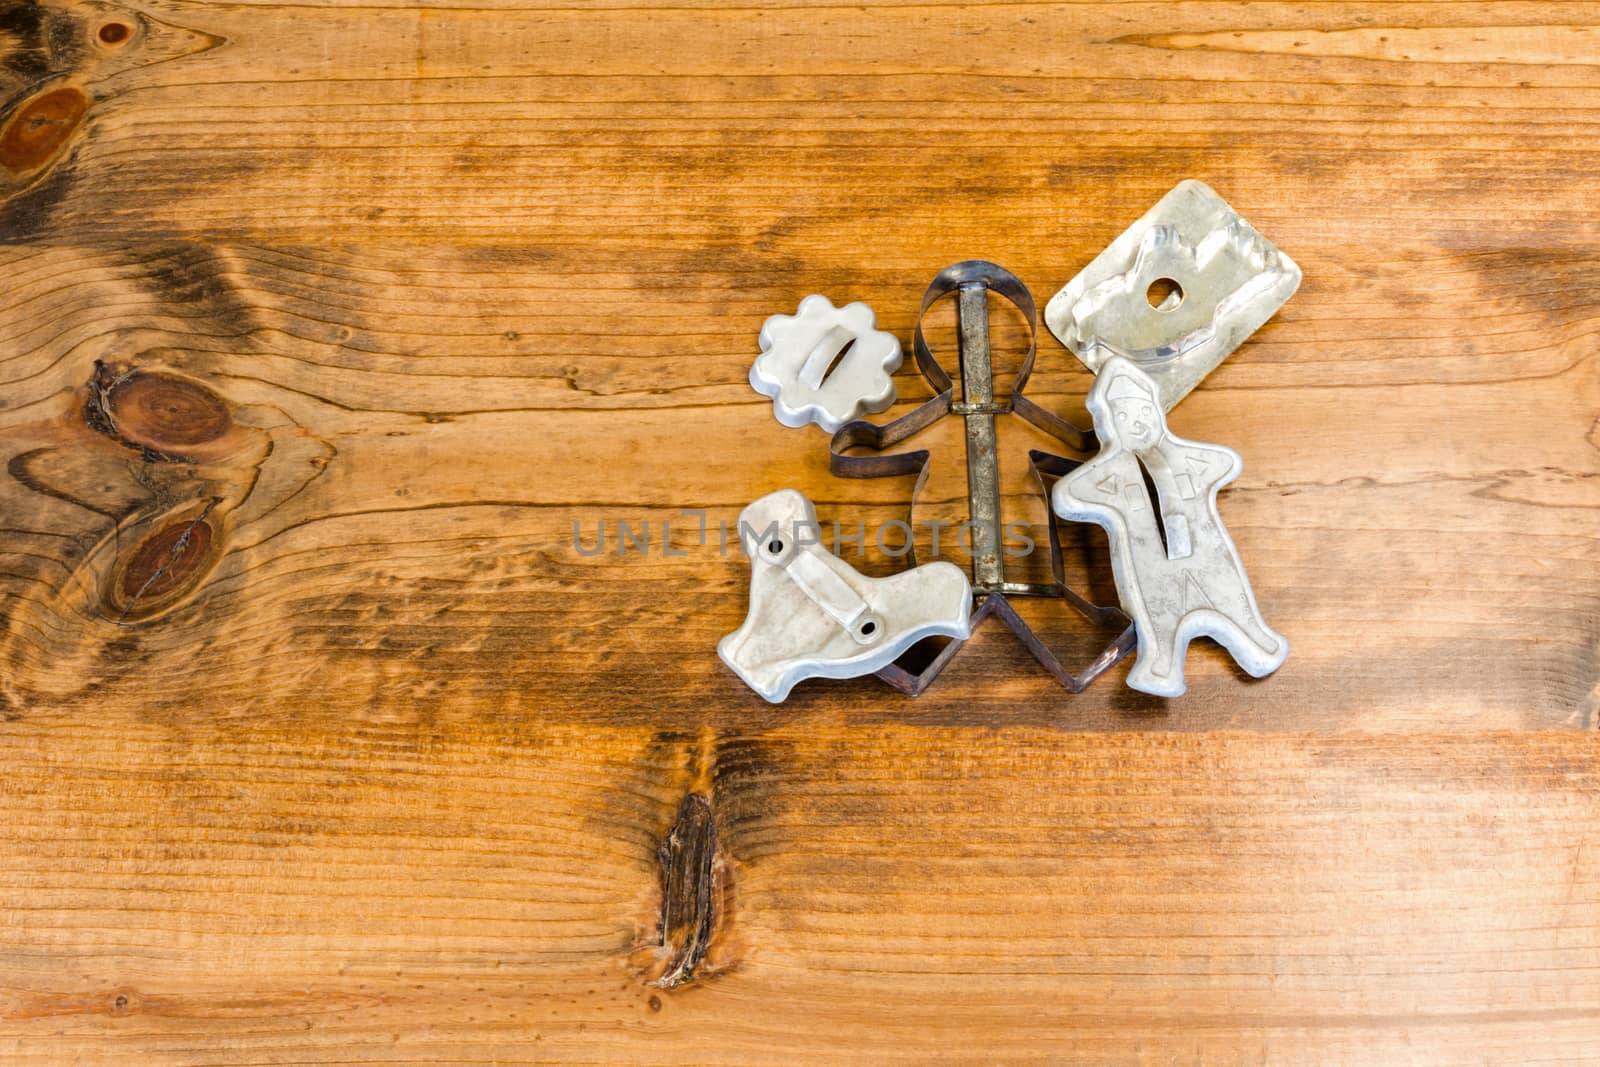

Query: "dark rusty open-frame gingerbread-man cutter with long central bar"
<box><xmin>829</xmin><ymin>259</ymin><xmax>1134</xmax><ymax>696</ymax></box>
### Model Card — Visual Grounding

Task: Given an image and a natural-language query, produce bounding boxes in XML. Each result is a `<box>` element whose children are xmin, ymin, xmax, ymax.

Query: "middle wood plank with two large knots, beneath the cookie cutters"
<box><xmin>0</xmin><ymin>238</ymin><xmax>1600</xmax><ymax>729</ymax></box>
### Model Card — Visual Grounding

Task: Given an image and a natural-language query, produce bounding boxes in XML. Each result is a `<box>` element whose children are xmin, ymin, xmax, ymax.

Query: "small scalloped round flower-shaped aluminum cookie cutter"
<box><xmin>750</xmin><ymin>293</ymin><xmax>902</xmax><ymax>434</ymax></box>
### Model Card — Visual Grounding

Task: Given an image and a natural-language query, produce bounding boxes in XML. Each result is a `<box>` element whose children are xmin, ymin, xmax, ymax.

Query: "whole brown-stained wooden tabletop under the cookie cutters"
<box><xmin>0</xmin><ymin>0</ymin><xmax>1600</xmax><ymax>1065</ymax></box>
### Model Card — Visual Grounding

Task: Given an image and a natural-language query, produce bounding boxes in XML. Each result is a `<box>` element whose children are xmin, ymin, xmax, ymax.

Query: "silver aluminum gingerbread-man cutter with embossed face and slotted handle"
<box><xmin>1051</xmin><ymin>357</ymin><xmax>1290</xmax><ymax>696</ymax></box>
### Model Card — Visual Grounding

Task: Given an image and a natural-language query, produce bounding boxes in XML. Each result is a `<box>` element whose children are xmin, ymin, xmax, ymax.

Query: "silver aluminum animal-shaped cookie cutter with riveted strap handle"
<box><xmin>717</xmin><ymin>490</ymin><xmax>973</xmax><ymax>704</ymax></box>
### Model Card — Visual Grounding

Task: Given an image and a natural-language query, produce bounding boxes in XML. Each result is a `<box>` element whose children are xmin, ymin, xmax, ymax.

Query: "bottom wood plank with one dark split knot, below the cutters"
<box><xmin>0</xmin><ymin>723</ymin><xmax>1600</xmax><ymax>1067</ymax></box>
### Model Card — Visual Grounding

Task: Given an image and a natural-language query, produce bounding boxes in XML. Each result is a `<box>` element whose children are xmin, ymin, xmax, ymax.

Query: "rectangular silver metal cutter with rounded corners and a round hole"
<box><xmin>1045</xmin><ymin>181</ymin><xmax>1301</xmax><ymax>411</ymax></box>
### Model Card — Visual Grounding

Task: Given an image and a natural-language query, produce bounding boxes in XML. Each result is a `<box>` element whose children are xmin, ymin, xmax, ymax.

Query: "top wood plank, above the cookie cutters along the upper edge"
<box><xmin>6</xmin><ymin>0</ymin><xmax>1600</xmax><ymax>244</ymax></box>
